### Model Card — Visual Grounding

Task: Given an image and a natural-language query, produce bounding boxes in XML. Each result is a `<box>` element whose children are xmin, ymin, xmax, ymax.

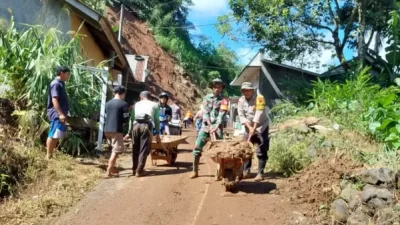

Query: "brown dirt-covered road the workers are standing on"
<box><xmin>52</xmin><ymin>130</ymin><xmax>293</xmax><ymax>225</ymax></box>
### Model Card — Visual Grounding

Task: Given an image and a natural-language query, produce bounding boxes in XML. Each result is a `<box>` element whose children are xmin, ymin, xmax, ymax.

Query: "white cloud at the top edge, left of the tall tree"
<box><xmin>190</xmin><ymin>0</ymin><xmax>229</xmax><ymax>18</ymax></box>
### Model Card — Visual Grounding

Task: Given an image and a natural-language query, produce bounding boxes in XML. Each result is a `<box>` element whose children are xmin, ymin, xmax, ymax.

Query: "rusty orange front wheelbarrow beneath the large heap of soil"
<box><xmin>211</xmin><ymin>133</ymin><xmax>251</xmax><ymax>191</ymax></box>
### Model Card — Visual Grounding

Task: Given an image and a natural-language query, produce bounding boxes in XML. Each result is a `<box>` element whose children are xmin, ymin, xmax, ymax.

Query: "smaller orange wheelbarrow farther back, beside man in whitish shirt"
<box><xmin>150</xmin><ymin>135</ymin><xmax>187</xmax><ymax>166</ymax></box>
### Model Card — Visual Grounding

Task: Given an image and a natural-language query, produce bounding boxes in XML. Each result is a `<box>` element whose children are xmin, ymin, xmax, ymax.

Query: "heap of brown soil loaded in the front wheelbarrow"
<box><xmin>206</xmin><ymin>140</ymin><xmax>254</xmax><ymax>159</ymax></box>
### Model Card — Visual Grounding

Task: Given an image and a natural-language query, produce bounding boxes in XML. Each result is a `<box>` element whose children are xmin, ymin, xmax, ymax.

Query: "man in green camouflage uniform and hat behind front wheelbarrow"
<box><xmin>190</xmin><ymin>79</ymin><xmax>228</xmax><ymax>179</ymax></box>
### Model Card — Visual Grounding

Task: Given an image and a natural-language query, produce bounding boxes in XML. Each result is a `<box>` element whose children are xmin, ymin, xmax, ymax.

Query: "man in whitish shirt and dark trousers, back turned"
<box><xmin>127</xmin><ymin>91</ymin><xmax>161</xmax><ymax>177</ymax></box>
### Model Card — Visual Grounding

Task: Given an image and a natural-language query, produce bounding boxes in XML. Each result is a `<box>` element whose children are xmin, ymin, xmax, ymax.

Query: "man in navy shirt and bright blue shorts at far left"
<box><xmin>46</xmin><ymin>66</ymin><xmax>70</xmax><ymax>159</ymax></box>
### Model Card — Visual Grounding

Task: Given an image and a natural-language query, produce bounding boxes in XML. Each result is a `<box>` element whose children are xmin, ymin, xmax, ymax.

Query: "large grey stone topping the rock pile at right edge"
<box><xmin>360</xmin><ymin>168</ymin><xmax>396</xmax><ymax>185</ymax></box>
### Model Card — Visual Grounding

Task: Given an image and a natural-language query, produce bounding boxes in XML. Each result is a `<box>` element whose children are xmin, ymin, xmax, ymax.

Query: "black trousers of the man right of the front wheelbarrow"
<box><xmin>243</xmin><ymin>127</ymin><xmax>269</xmax><ymax>173</ymax></box>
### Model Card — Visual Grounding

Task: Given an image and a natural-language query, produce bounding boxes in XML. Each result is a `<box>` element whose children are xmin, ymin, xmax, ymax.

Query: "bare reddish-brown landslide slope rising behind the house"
<box><xmin>106</xmin><ymin>7</ymin><xmax>202</xmax><ymax>110</ymax></box>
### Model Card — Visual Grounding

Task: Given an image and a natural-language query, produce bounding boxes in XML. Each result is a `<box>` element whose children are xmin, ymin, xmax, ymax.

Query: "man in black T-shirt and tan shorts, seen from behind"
<box><xmin>104</xmin><ymin>86</ymin><xmax>129</xmax><ymax>178</ymax></box>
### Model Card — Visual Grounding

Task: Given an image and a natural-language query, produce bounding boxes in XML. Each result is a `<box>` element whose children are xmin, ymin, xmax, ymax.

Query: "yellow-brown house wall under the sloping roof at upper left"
<box><xmin>71</xmin><ymin>13</ymin><xmax>107</xmax><ymax>67</ymax></box>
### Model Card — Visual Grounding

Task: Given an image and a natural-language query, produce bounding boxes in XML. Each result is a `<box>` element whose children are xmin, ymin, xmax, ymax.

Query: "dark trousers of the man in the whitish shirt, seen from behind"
<box><xmin>132</xmin><ymin>123</ymin><xmax>153</xmax><ymax>172</ymax></box>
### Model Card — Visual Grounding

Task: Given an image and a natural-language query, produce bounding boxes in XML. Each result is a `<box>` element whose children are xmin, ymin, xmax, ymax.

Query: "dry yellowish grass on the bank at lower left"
<box><xmin>0</xmin><ymin>140</ymin><xmax>102</xmax><ymax>225</ymax></box>
